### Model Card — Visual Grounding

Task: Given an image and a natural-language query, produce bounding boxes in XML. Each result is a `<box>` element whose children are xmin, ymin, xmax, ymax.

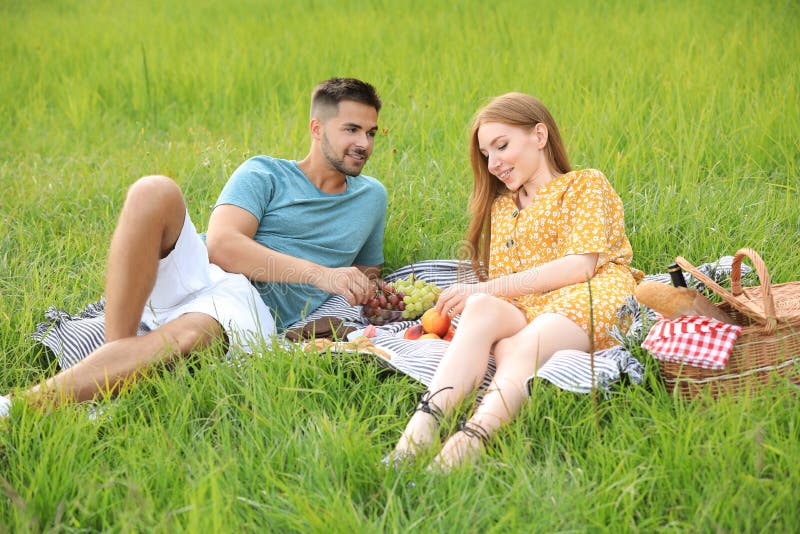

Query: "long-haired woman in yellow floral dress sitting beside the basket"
<box><xmin>390</xmin><ymin>93</ymin><xmax>641</xmax><ymax>470</ymax></box>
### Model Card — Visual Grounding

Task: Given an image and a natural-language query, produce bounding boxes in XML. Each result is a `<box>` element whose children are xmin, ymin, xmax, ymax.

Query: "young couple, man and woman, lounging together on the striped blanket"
<box><xmin>0</xmin><ymin>78</ymin><xmax>636</xmax><ymax>470</ymax></box>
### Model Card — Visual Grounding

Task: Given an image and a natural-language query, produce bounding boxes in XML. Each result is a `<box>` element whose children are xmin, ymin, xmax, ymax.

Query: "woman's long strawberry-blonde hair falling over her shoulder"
<box><xmin>467</xmin><ymin>93</ymin><xmax>571</xmax><ymax>280</ymax></box>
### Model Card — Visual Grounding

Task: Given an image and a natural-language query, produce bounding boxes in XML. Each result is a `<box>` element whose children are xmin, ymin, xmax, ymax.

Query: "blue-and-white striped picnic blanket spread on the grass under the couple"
<box><xmin>31</xmin><ymin>256</ymin><xmax>748</xmax><ymax>393</ymax></box>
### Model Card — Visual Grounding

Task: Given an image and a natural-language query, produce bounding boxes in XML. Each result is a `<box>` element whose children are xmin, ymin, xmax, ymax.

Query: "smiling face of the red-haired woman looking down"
<box><xmin>478</xmin><ymin>122</ymin><xmax>550</xmax><ymax>191</ymax></box>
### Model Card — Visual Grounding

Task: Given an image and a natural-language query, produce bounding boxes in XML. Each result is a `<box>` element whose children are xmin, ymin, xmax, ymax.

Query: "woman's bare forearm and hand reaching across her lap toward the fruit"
<box><xmin>436</xmin><ymin>253</ymin><xmax>598</xmax><ymax>315</ymax></box>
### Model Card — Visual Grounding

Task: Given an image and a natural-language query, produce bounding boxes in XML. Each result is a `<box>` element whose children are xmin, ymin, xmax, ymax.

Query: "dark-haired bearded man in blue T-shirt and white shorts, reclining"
<box><xmin>0</xmin><ymin>78</ymin><xmax>387</xmax><ymax>416</ymax></box>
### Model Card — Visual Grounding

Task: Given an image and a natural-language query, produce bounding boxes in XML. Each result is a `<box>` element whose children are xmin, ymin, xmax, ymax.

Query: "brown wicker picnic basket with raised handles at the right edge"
<box><xmin>658</xmin><ymin>248</ymin><xmax>800</xmax><ymax>398</ymax></box>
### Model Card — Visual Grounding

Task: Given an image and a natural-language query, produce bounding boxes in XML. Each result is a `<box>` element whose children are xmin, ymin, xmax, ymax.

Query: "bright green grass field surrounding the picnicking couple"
<box><xmin>0</xmin><ymin>0</ymin><xmax>800</xmax><ymax>532</ymax></box>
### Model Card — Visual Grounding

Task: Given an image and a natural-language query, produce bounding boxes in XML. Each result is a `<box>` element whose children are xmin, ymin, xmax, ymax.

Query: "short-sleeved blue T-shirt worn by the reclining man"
<box><xmin>215</xmin><ymin>156</ymin><xmax>387</xmax><ymax>328</ymax></box>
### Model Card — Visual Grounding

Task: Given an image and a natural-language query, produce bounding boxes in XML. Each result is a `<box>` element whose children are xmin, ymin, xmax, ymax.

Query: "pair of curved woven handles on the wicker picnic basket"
<box><xmin>675</xmin><ymin>249</ymin><xmax>776</xmax><ymax>334</ymax></box>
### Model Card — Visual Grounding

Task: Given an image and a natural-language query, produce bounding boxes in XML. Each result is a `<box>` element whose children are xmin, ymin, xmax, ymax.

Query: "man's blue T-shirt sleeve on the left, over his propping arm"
<box><xmin>214</xmin><ymin>157</ymin><xmax>275</xmax><ymax>221</ymax></box>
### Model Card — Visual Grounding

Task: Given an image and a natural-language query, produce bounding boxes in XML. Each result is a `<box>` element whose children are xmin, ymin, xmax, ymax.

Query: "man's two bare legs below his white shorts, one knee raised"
<box><xmin>5</xmin><ymin>176</ymin><xmax>224</xmax><ymax>404</ymax></box>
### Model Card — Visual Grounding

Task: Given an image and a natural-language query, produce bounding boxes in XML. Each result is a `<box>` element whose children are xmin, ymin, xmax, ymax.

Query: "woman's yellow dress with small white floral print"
<box><xmin>489</xmin><ymin>169</ymin><xmax>643</xmax><ymax>350</ymax></box>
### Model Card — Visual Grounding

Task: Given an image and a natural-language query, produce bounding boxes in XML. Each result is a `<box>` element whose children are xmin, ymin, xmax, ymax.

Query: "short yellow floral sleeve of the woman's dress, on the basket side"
<box><xmin>558</xmin><ymin>169</ymin><xmax>625</xmax><ymax>268</ymax></box>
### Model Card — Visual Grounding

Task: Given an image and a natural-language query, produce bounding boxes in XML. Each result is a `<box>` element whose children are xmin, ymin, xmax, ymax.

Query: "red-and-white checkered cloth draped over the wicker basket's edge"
<box><xmin>642</xmin><ymin>315</ymin><xmax>742</xmax><ymax>369</ymax></box>
